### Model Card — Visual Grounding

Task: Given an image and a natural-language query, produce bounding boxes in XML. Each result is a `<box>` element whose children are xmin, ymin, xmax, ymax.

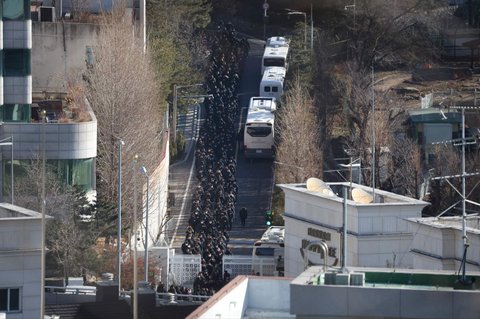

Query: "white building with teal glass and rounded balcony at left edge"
<box><xmin>0</xmin><ymin>0</ymin><xmax>97</xmax><ymax>203</ymax></box>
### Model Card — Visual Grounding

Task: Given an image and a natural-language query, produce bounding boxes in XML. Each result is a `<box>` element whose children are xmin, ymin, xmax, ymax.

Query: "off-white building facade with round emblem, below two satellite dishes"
<box><xmin>279</xmin><ymin>183</ymin><xmax>428</xmax><ymax>277</ymax></box>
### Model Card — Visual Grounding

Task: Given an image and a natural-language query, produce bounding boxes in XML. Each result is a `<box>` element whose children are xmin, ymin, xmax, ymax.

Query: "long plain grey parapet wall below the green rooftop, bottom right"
<box><xmin>290</xmin><ymin>284</ymin><xmax>480</xmax><ymax>319</ymax></box>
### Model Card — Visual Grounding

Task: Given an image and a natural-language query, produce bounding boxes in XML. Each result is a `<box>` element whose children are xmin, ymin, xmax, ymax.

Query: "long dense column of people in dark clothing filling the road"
<box><xmin>182</xmin><ymin>25</ymin><xmax>249</xmax><ymax>294</ymax></box>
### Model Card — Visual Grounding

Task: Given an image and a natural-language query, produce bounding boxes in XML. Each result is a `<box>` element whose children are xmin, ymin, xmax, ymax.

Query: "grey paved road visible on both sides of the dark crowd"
<box><xmin>167</xmin><ymin>40</ymin><xmax>273</xmax><ymax>254</ymax></box>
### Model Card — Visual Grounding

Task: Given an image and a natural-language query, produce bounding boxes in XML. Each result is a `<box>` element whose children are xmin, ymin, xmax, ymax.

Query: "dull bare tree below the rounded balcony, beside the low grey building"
<box><xmin>15</xmin><ymin>156</ymin><xmax>98</xmax><ymax>277</ymax></box>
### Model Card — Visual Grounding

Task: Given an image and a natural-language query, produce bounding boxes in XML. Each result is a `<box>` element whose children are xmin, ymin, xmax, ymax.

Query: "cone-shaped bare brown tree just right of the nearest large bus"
<box><xmin>275</xmin><ymin>78</ymin><xmax>323</xmax><ymax>183</ymax></box>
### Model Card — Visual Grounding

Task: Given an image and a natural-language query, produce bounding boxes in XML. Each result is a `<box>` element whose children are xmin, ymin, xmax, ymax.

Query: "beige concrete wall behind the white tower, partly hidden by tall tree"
<box><xmin>32</xmin><ymin>21</ymin><xmax>99</xmax><ymax>92</ymax></box>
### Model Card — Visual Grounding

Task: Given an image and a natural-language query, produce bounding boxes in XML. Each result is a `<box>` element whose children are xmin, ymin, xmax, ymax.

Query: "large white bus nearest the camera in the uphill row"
<box><xmin>243</xmin><ymin>97</ymin><xmax>276</xmax><ymax>158</ymax></box>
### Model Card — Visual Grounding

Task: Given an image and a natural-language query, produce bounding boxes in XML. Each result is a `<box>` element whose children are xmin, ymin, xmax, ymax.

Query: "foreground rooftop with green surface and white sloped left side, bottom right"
<box><xmin>187</xmin><ymin>266</ymin><xmax>480</xmax><ymax>319</ymax></box>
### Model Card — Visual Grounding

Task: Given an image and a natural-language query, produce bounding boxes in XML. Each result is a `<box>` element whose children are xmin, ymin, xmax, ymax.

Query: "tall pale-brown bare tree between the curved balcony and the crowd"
<box><xmin>85</xmin><ymin>7</ymin><xmax>163</xmax><ymax>230</ymax></box>
